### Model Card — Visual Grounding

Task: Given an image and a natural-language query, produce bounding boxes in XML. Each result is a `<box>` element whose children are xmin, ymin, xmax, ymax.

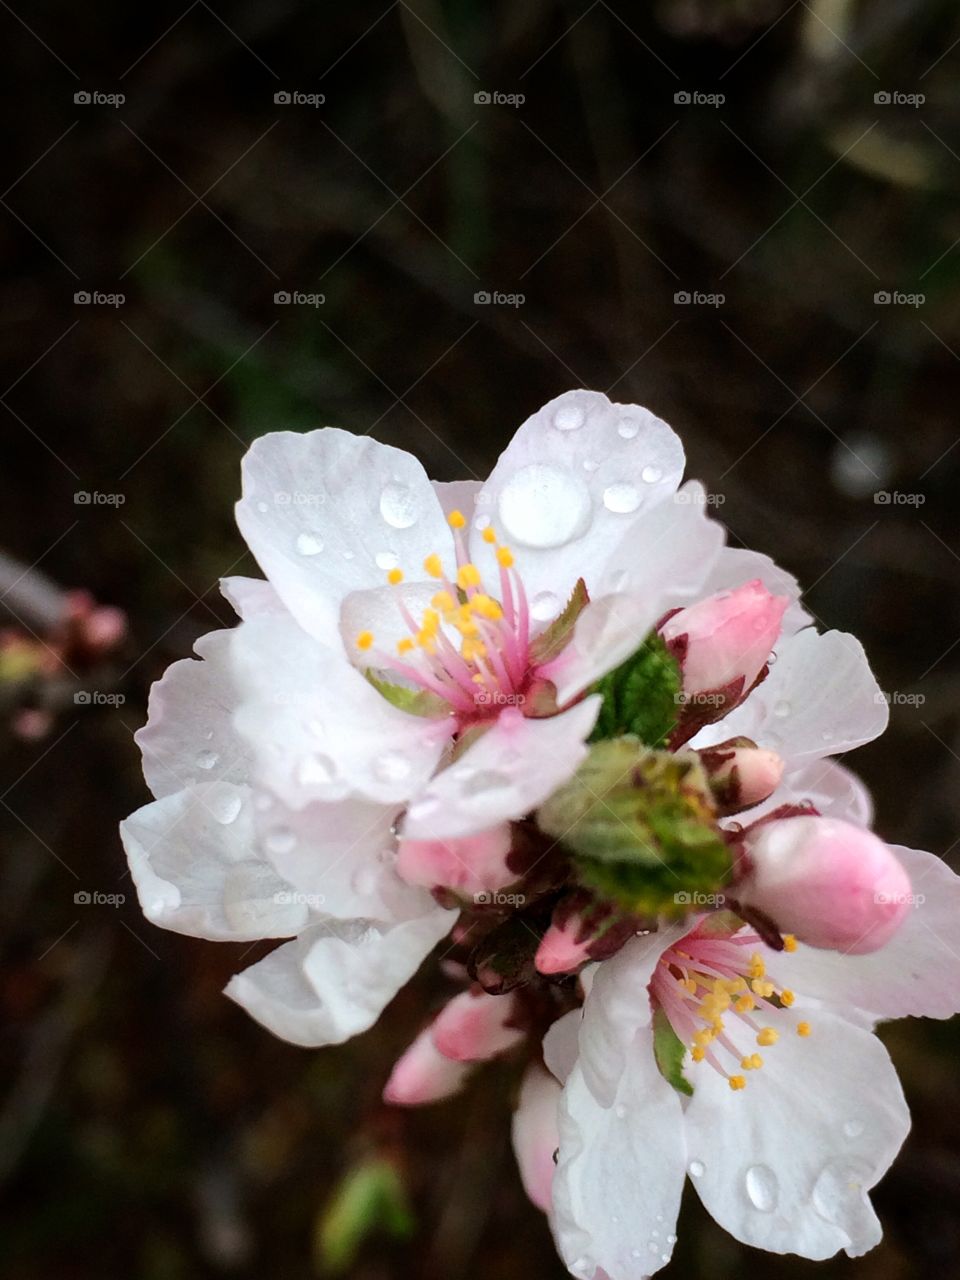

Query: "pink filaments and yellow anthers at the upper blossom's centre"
<box><xmin>356</xmin><ymin>511</ymin><xmax>530</xmax><ymax>717</ymax></box>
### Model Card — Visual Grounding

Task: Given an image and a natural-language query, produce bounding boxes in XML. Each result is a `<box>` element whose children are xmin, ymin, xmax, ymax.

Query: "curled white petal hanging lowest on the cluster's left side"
<box><xmin>225</xmin><ymin>908</ymin><xmax>456</xmax><ymax>1047</ymax></box>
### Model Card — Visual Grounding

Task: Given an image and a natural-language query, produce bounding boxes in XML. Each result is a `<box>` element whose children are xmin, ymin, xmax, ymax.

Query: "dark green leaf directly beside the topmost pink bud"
<box><xmin>590</xmin><ymin>632</ymin><xmax>682</xmax><ymax>746</ymax></box>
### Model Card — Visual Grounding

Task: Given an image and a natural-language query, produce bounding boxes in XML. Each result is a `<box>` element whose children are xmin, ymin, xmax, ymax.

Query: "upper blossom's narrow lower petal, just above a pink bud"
<box><xmin>403</xmin><ymin>696</ymin><xmax>600</xmax><ymax>840</ymax></box>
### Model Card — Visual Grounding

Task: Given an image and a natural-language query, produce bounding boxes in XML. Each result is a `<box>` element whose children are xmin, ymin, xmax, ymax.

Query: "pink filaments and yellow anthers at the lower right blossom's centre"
<box><xmin>650</xmin><ymin>925</ymin><xmax>810</xmax><ymax>1092</ymax></box>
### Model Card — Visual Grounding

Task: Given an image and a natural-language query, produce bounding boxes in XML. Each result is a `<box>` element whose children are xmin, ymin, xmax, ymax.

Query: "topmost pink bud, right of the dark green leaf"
<box><xmin>660</xmin><ymin>579</ymin><xmax>790</xmax><ymax>709</ymax></box>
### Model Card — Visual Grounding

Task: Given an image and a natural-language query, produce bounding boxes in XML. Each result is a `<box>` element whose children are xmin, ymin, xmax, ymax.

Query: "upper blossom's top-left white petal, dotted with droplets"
<box><xmin>237</xmin><ymin>428</ymin><xmax>452</xmax><ymax>637</ymax></box>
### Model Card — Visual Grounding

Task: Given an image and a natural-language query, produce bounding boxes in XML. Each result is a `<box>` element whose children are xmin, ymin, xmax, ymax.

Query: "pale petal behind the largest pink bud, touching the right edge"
<box><xmin>768</xmin><ymin>845</ymin><xmax>960</xmax><ymax>1019</ymax></box>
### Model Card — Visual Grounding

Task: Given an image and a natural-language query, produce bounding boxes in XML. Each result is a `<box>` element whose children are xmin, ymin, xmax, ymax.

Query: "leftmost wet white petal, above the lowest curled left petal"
<box><xmin>120</xmin><ymin>782</ymin><xmax>308</xmax><ymax>942</ymax></box>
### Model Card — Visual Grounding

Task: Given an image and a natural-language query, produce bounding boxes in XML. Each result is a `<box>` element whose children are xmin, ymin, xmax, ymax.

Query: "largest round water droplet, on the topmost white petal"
<box><xmin>497</xmin><ymin>462</ymin><xmax>591</xmax><ymax>547</ymax></box>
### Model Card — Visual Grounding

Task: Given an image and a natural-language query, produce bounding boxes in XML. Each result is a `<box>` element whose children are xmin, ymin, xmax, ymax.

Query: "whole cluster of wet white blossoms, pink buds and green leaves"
<box><xmin>123</xmin><ymin>390</ymin><xmax>960</xmax><ymax>1280</ymax></box>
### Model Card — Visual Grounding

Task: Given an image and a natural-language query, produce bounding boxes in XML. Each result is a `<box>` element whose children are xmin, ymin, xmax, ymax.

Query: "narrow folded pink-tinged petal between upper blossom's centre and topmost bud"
<box><xmin>544</xmin><ymin>481</ymin><xmax>724</xmax><ymax>705</ymax></box>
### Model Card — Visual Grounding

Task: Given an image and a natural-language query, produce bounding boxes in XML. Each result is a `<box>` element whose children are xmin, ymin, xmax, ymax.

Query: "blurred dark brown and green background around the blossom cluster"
<box><xmin>0</xmin><ymin>0</ymin><xmax>960</xmax><ymax>1280</ymax></box>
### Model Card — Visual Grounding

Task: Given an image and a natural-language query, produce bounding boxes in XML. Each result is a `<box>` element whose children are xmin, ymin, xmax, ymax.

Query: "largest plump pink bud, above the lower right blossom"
<box><xmin>733</xmin><ymin>817</ymin><xmax>911</xmax><ymax>955</ymax></box>
